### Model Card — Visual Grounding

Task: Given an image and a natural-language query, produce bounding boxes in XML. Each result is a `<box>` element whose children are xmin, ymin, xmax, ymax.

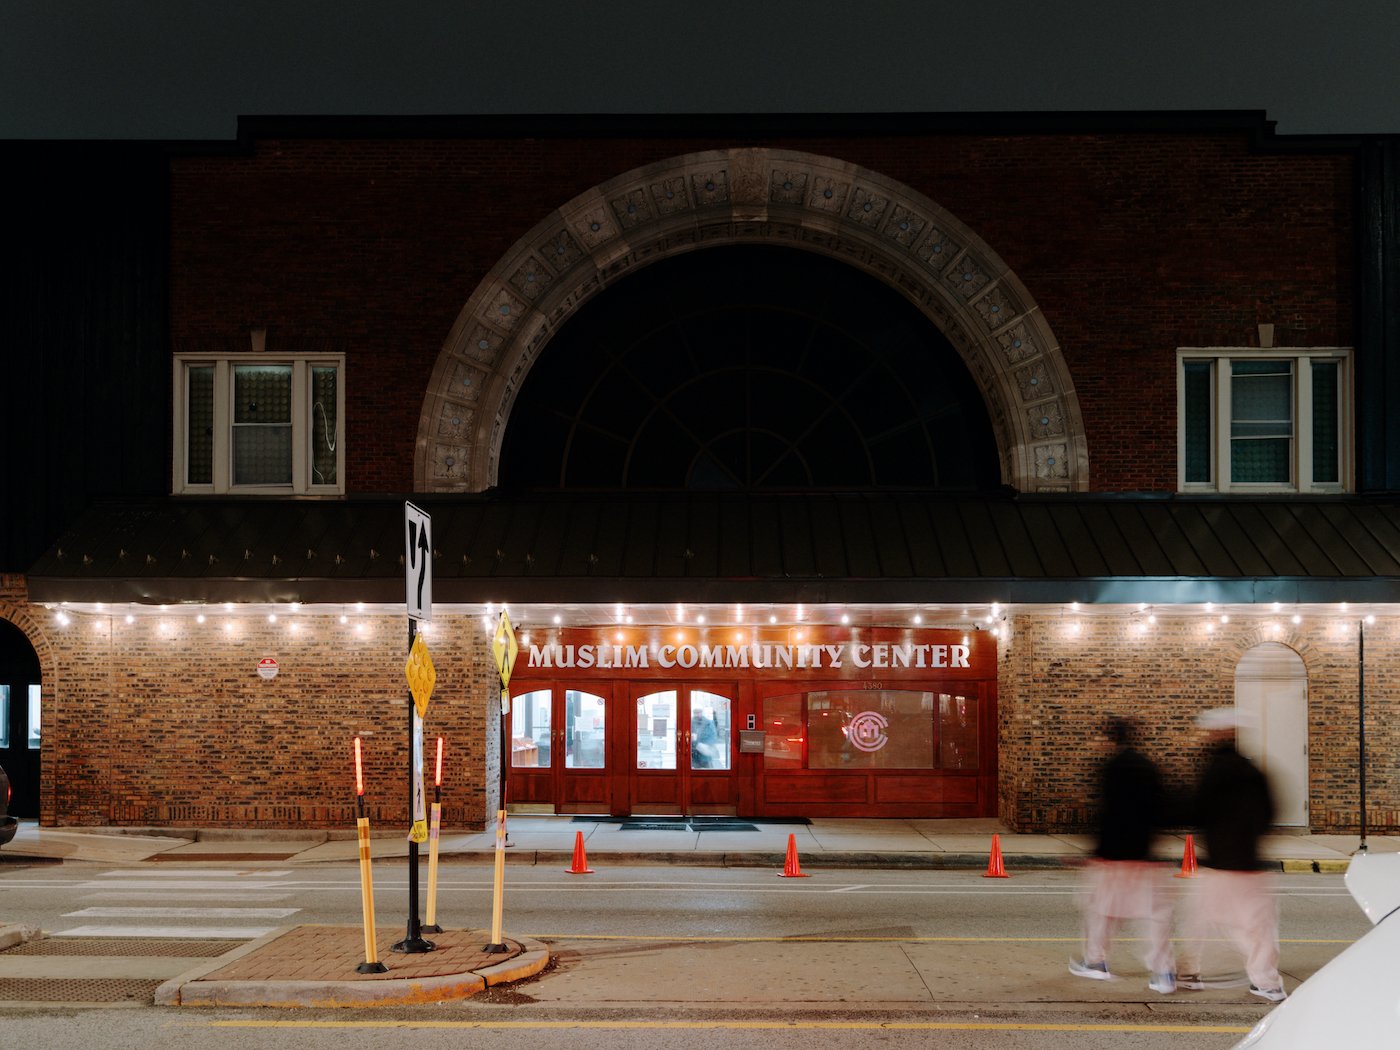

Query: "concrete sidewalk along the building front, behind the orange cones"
<box><xmin>0</xmin><ymin>815</ymin><xmax>1377</xmax><ymax>871</ymax></box>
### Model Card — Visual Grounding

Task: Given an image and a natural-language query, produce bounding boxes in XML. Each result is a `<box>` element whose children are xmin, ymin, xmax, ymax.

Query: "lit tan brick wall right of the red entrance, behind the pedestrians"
<box><xmin>998</xmin><ymin>612</ymin><xmax>1400</xmax><ymax>833</ymax></box>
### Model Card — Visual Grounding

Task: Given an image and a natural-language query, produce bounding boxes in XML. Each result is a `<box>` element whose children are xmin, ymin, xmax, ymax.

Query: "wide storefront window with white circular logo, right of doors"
<box><xmin>763</xmin><ymin>689</ymin><xmax>979</xmax><ymax>770</ymax></box>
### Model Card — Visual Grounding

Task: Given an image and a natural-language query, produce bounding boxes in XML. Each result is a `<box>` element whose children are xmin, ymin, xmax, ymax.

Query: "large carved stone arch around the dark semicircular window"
<box><xmin>413</xmin><ymin>148</ymin><xmax>1089</xmax><ymax>491</ymax></box>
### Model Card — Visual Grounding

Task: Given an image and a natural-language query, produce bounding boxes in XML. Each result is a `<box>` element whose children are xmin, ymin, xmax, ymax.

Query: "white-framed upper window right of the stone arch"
<box><xmin>1176</xmin><ymin>347</ymin><xmax>1352</xmax><ymax>493</ymax></box>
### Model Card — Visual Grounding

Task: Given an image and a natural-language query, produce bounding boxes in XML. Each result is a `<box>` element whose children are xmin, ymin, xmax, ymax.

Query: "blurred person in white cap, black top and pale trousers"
<box><xmin>1179</xmin><ymin>707</ymin><xmax>1287</xmax><ymax>1002</ymax></box>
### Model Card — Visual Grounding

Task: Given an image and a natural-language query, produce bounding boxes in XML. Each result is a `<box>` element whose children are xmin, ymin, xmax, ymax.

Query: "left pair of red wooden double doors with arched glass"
<box><xmin>507</xmin><ymin>682</ymin><xmax>616</xmax><ymax>813</ymax></box>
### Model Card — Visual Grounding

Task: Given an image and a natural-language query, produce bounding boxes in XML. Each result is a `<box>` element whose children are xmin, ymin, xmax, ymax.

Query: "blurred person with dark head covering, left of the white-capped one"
<box><xmin>1070</xmin><ymin>718</ymin><xmax>1176</xmax><ymax>995</ymax></box>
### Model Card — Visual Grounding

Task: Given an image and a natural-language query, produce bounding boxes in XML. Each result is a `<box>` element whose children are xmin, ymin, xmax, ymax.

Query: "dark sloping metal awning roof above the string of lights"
<box><xmin>28</xmin><ymin>491</ymin><xmax>1400</xmax><ymax>605</ymax></box>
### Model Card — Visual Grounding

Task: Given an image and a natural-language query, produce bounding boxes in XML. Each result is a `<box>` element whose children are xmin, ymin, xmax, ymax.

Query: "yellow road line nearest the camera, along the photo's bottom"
<box><xmin>191</xmin><ymin>1021</ymin><xmax>1250</xmax><ymax>1035</ymax></box>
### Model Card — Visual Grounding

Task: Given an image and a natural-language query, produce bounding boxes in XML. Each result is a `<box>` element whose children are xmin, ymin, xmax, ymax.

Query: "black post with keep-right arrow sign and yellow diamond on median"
<box><xmin>393</xmin><ymin>503</ymin><xmax>437</xmax><ymax>953</ymax></box>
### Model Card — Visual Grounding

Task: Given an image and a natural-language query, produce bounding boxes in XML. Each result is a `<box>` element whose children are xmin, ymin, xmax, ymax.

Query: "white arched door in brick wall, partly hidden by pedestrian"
<box><xmin>1235</xmin><ymin>641</ymin><xmax>1308</xmax><ymax>827</ymax></box>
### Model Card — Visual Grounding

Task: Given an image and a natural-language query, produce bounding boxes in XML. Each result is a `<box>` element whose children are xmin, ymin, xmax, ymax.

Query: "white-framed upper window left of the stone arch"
<box><xmin>172</xmin><ymin>353</ymin><xmax>344</xmax><ymax>496</ymax></box>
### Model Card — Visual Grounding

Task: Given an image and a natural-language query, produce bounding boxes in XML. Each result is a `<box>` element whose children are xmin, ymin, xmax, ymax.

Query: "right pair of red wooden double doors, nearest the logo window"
<box><xmin>627</xmin><ymin>682</ymin><xmax>738</xmax><ymax>815</ymax></box>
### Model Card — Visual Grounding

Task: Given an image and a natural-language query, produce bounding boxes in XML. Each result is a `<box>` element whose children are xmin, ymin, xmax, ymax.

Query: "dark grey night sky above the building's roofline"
<box><xmin>0</xmin><ymin>0</ymin><xmax>1400</xmax><ymax>139</ymax></box>
